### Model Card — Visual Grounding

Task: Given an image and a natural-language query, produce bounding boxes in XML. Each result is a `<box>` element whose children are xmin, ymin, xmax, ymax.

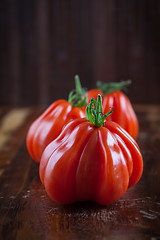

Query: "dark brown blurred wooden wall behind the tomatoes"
<box><xmin>0</xmin><ymin>0</ymin><xmax>160</xmax><ymax>105</ymax></box>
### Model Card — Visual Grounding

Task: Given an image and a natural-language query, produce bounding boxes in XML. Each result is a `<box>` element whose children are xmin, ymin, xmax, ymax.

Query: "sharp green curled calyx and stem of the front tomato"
<box><xmin>86</xmin><ymin>94</ymin><xmax>114</xmax><ymax>127</ymax></box>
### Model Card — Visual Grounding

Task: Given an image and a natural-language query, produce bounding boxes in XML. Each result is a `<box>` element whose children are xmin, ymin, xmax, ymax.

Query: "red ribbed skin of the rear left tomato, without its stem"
<box><xmin>27</xmin><ymin>100</ymin><xmax>85</xmax><ymax>163</ymax></box>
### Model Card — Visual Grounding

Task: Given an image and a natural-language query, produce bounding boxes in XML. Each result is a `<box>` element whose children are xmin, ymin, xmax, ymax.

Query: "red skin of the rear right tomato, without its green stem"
<box><xmin>88</xmin><ymin>89</ymin><xmax>139</xmax><ymax>139</ymax></box>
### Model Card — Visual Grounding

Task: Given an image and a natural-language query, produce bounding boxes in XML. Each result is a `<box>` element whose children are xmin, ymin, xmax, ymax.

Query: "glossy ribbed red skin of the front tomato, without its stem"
<box><xmin>39</xmin><ymin>118</ymin><xmax>143</xmax><ymax>205</ymax></box>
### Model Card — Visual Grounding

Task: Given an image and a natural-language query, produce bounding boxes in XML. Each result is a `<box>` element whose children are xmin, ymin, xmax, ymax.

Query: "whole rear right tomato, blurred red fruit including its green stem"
<box><xmin>87</xmin><ymin>80</ymin><xmax>139</xmax><ymax>139</ymax></box>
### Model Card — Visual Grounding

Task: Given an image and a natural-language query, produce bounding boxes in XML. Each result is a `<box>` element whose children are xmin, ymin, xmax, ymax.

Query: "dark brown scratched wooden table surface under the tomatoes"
<box><xmin>0</xmin><ymin>105</ymin><xmax>160</xmax><ymax>240</ymax></box>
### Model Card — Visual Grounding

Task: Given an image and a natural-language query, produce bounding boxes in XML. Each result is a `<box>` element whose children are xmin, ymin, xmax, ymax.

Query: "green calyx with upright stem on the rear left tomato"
<box><xmin>68</xmin><ymin>75</ymin><xmax>87</xmax><ymax>108</ymax></box>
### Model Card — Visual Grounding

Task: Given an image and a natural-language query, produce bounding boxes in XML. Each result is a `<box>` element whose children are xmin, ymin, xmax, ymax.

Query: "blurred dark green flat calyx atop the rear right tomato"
<box><xmin>97</xmin><ymin>80</ymin><xmax>132</xmax><ymax>94</ymax></box>
